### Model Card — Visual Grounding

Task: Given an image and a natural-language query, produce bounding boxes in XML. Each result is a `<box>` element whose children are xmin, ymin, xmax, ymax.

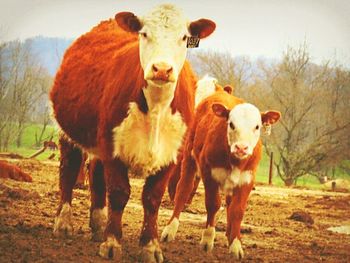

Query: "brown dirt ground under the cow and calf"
<box><xmin>0</xmin><ymin>160</ymin><xmax>350</xmax><ymax>262</ymax></box>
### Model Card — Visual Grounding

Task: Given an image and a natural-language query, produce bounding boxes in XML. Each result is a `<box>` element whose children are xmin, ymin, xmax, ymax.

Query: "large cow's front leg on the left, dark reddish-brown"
<box><xmin>99</xmin><ymin>159</ymin><xmax>130</xmax><ymax>260</ymax></box>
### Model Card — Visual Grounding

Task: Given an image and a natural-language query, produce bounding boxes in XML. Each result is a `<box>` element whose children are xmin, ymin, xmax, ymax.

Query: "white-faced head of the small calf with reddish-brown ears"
<box><xmin>212</xmin><ymin>103</ymin><xmax>281</xmax><ymax>159</ymax></box>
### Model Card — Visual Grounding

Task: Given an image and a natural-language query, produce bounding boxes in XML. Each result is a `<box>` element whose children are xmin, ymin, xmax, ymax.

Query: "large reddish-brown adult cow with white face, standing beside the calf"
<box><xmin>50</xmin><ymin>4</ymin><xmax>216</xmax><ymax>262</ymax></box>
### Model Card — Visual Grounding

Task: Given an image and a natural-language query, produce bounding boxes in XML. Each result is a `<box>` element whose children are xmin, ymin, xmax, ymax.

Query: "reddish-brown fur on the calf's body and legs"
<box><xmin>169</xmin><ymin>89</ymin><xmax>262</xmax><ymax>244</ymax></box>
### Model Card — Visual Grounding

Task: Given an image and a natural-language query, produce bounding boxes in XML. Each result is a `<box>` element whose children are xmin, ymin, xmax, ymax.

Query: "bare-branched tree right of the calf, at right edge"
<box><xmin>249</xmin><ymin>45</ymin><xmax>350</xmax><ymax>185</ymax></box>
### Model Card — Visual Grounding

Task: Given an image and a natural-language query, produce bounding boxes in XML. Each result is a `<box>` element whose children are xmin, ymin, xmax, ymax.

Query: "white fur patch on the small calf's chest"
<box><xmin>211</xmin><ymin>168</ymin><xmax>253</xmax><ymax>193</ymax></box>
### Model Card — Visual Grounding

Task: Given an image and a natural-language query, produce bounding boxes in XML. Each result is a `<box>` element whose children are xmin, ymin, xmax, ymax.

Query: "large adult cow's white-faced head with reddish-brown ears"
<box><xmin>115</xmin><ymin>4</ymin><xmax>215</xmax><ymax>87</ymax></box>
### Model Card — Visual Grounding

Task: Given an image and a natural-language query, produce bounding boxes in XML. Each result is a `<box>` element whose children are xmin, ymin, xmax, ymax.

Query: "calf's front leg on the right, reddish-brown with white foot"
<box><xmin>226</xmin><ymin>183</ymin><xmax>253</xmax><ymax>259</ymax></box>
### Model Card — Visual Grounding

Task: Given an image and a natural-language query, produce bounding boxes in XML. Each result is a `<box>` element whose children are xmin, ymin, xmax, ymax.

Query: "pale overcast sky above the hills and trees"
<box><xmin>0</xmin><ymin>0</ymin><xmax>350</xmax><ymax>68</ymax></box>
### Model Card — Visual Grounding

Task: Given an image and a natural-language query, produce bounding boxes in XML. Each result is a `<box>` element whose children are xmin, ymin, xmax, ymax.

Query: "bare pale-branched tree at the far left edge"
<box><xmin>0</xmin><ymin>41</ymin><xmax>52</xmax><ymax>150</ymax></box>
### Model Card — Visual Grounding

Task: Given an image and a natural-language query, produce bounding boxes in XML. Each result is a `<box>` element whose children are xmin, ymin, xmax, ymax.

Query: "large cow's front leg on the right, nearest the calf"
<box><xmin>140</xmin><ymin>169</ymin><xmax>169</xmax><ymax>263</ymax></box>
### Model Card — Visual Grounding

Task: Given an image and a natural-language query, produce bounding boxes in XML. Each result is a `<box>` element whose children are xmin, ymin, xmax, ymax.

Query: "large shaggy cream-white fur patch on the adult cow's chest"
<box><xmin>113</xmin><ymin>103</ymin><xmax>186</xmax><ymax>176</ymax></box>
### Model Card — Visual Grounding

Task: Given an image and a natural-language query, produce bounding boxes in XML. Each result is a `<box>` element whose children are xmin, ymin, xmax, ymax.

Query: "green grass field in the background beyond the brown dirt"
<box><xmin>4</xmin><ymin>124</ymin><xmax>350</xmax><ymax>189</ymax></box>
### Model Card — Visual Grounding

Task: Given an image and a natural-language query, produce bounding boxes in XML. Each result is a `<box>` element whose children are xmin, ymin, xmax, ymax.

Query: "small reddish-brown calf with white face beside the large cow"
<box><xmin>161</xmin><ymin>90</ymin><xmax>280</xmax><ymax>259</ymax></box>
